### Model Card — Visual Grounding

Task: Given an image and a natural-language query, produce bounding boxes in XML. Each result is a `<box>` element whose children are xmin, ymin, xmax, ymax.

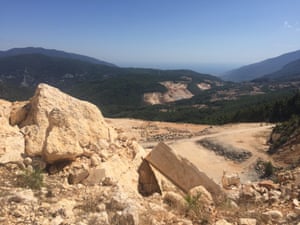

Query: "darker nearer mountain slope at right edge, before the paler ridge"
<box><xmin>254</xmin><ymin>59</ymin><xmax>300</xmax><ymax>82</ymax></box>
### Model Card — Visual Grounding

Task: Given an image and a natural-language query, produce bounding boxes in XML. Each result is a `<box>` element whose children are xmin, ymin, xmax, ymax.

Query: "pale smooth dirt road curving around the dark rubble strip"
<box><xmin>169</xmin><ymin>124</ymin><xmax>272</xmax><ymax>183</ymax></box>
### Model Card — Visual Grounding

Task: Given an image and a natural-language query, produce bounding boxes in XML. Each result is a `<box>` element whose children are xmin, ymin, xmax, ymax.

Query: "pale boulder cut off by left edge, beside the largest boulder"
<box><xmin>0</xmin><ymin>100</ymin><xmax>25</xmax><ymax>164</ymax></box>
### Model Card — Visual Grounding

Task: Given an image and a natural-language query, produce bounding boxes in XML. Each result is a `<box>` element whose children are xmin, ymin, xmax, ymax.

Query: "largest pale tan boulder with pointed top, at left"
<box><xmin>18</xmin><ymin>84</ymin><xmax>115</xmax><ymax>163</ymax></box>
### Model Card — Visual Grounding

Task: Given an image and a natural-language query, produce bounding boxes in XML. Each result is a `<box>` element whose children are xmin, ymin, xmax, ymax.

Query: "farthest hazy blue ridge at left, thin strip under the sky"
<box><xmin>0</xmin><ymin>47</ymin><xmax>116</xmax><ymax>66</ymax></box>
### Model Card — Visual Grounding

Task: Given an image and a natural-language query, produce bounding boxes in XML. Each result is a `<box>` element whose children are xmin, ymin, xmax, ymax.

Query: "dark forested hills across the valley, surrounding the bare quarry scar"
<box><xmin>0</xmin><ymin>48</ymin><xmax>300</xmax><ymax>124</ymax></box>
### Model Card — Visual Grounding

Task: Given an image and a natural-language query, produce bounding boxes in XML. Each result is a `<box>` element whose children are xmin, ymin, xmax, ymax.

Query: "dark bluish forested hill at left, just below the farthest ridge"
<box><xmin>0</xmin><ymin>53</ymin><xmax>119</xmax><ymax>88</ymax></box>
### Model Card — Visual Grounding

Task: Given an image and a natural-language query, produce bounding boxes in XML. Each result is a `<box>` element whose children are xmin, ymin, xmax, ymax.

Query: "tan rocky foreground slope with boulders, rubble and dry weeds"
<box><xmin>0</xmin><ymin>84</ymin><xmax>300</xmax><ymax>225</ymax></box>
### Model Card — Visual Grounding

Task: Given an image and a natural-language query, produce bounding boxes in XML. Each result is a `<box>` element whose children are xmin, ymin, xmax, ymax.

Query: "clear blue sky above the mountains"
<box><xmin>0</xmin><ymin>0</ymin><xmax>300</xmax><ymax>73</ymax></box>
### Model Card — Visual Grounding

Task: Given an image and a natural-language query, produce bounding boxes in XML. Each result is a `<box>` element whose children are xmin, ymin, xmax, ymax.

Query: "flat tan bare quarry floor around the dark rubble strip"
<box><xmin>107</xmin><ymin>119</ymin><xmax>273</xmax><ymax>183</ymax></box>
